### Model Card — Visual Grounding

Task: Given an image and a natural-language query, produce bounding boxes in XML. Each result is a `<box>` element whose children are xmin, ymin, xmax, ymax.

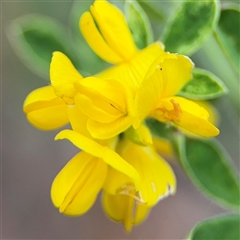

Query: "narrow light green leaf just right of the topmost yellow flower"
<box><xmin>124</xmin><ymin>1</ymin><xmax>153</xmax><ymax>49</ymax></box>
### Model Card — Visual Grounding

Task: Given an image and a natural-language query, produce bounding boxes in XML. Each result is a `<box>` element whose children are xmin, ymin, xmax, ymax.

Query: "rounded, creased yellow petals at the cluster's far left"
<box><xmin>23</xmin><ymin>86</ymin><xmax>68</xmax><ymax>130</ymax></box>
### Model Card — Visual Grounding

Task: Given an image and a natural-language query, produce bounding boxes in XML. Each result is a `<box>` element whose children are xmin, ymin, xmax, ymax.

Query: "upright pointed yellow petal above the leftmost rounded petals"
<box><xmin>50</xmin><ymin>52</ymin><xmax>83</xmax><ymax>98</ymax></box>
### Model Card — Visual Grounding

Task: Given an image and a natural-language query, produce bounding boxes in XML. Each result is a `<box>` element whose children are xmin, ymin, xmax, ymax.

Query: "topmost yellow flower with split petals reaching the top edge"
<box><xmin>79</xmin><ymin>0</ymin><xmax>164</xmax><ymax>93</ymax></box>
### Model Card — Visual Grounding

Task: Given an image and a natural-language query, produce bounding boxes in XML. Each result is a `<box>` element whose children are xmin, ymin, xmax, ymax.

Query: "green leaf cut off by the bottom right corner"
<box><xmin>188</xmin><ymin>215</ymin><xmax>240</xmax><ymax>240</ymax></box>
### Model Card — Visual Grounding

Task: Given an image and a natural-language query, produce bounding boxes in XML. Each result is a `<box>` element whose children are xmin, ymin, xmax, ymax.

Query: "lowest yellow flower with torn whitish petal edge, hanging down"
<box><xmin>102</xmin><ymin>140</ymin><xmax>176</xmax><ymax>231</ymax></box>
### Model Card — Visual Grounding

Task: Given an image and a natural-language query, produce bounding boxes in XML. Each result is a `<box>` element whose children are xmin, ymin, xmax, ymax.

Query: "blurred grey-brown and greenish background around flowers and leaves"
<box><xmin>1</xmin><ymin>1</ymin><xmax>239</xmax><ymax>239</ymax></box>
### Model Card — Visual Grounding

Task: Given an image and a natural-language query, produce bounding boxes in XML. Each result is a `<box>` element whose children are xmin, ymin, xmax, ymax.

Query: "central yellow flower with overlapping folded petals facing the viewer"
<box><xmin>75</xmin><ymin>77</ymin><xmax>136</xmax><ymax>139</ymax></box>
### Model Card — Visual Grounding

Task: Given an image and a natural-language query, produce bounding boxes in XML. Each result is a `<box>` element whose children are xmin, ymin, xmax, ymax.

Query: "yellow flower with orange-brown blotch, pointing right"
<box><xmin>135</xmin><ymin>53</ymin><xmax>219</xmax><ymax>137</ymax></box>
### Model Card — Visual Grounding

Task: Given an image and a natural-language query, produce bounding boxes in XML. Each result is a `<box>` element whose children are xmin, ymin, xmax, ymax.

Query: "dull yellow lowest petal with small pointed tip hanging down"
<box><xmin>102</xmin><ymin>191</ymin><xmax>150</xmax><ymax>232</ymax></box>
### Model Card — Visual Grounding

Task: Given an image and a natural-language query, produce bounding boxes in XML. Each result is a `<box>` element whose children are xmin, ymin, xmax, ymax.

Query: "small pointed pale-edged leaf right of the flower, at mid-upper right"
<box><xmin>179</xmin><ymin>68</ymin><xmax>227</xmax><ymax>100</ymax></box>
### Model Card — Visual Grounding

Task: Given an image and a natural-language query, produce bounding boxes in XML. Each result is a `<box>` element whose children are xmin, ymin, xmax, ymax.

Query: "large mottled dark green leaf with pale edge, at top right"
<box><xmin>161</xmin><ymin>0</ymin><xmax>219</xmax><ymax>55</ymax></box>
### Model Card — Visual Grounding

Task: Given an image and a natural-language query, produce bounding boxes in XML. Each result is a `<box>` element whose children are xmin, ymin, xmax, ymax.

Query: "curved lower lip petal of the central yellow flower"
<box><xmin>87</xmin><ymin>116</ymin><xmax>133</xmax><ymax>139</ymax></box>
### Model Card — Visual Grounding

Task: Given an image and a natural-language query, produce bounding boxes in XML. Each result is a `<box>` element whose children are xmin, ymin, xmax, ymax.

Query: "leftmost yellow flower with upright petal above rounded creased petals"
<box><xmin>23</xmin><ymin>52</ymin><xmax>83</xmax><ymax>130</ymax></box>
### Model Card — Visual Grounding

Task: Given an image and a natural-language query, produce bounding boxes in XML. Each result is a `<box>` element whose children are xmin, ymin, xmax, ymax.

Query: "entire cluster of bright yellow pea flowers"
<box><xmin>24</xmin><ymin>0</ymin><xmax>219</xmax><ymax>231</ymax></box>
